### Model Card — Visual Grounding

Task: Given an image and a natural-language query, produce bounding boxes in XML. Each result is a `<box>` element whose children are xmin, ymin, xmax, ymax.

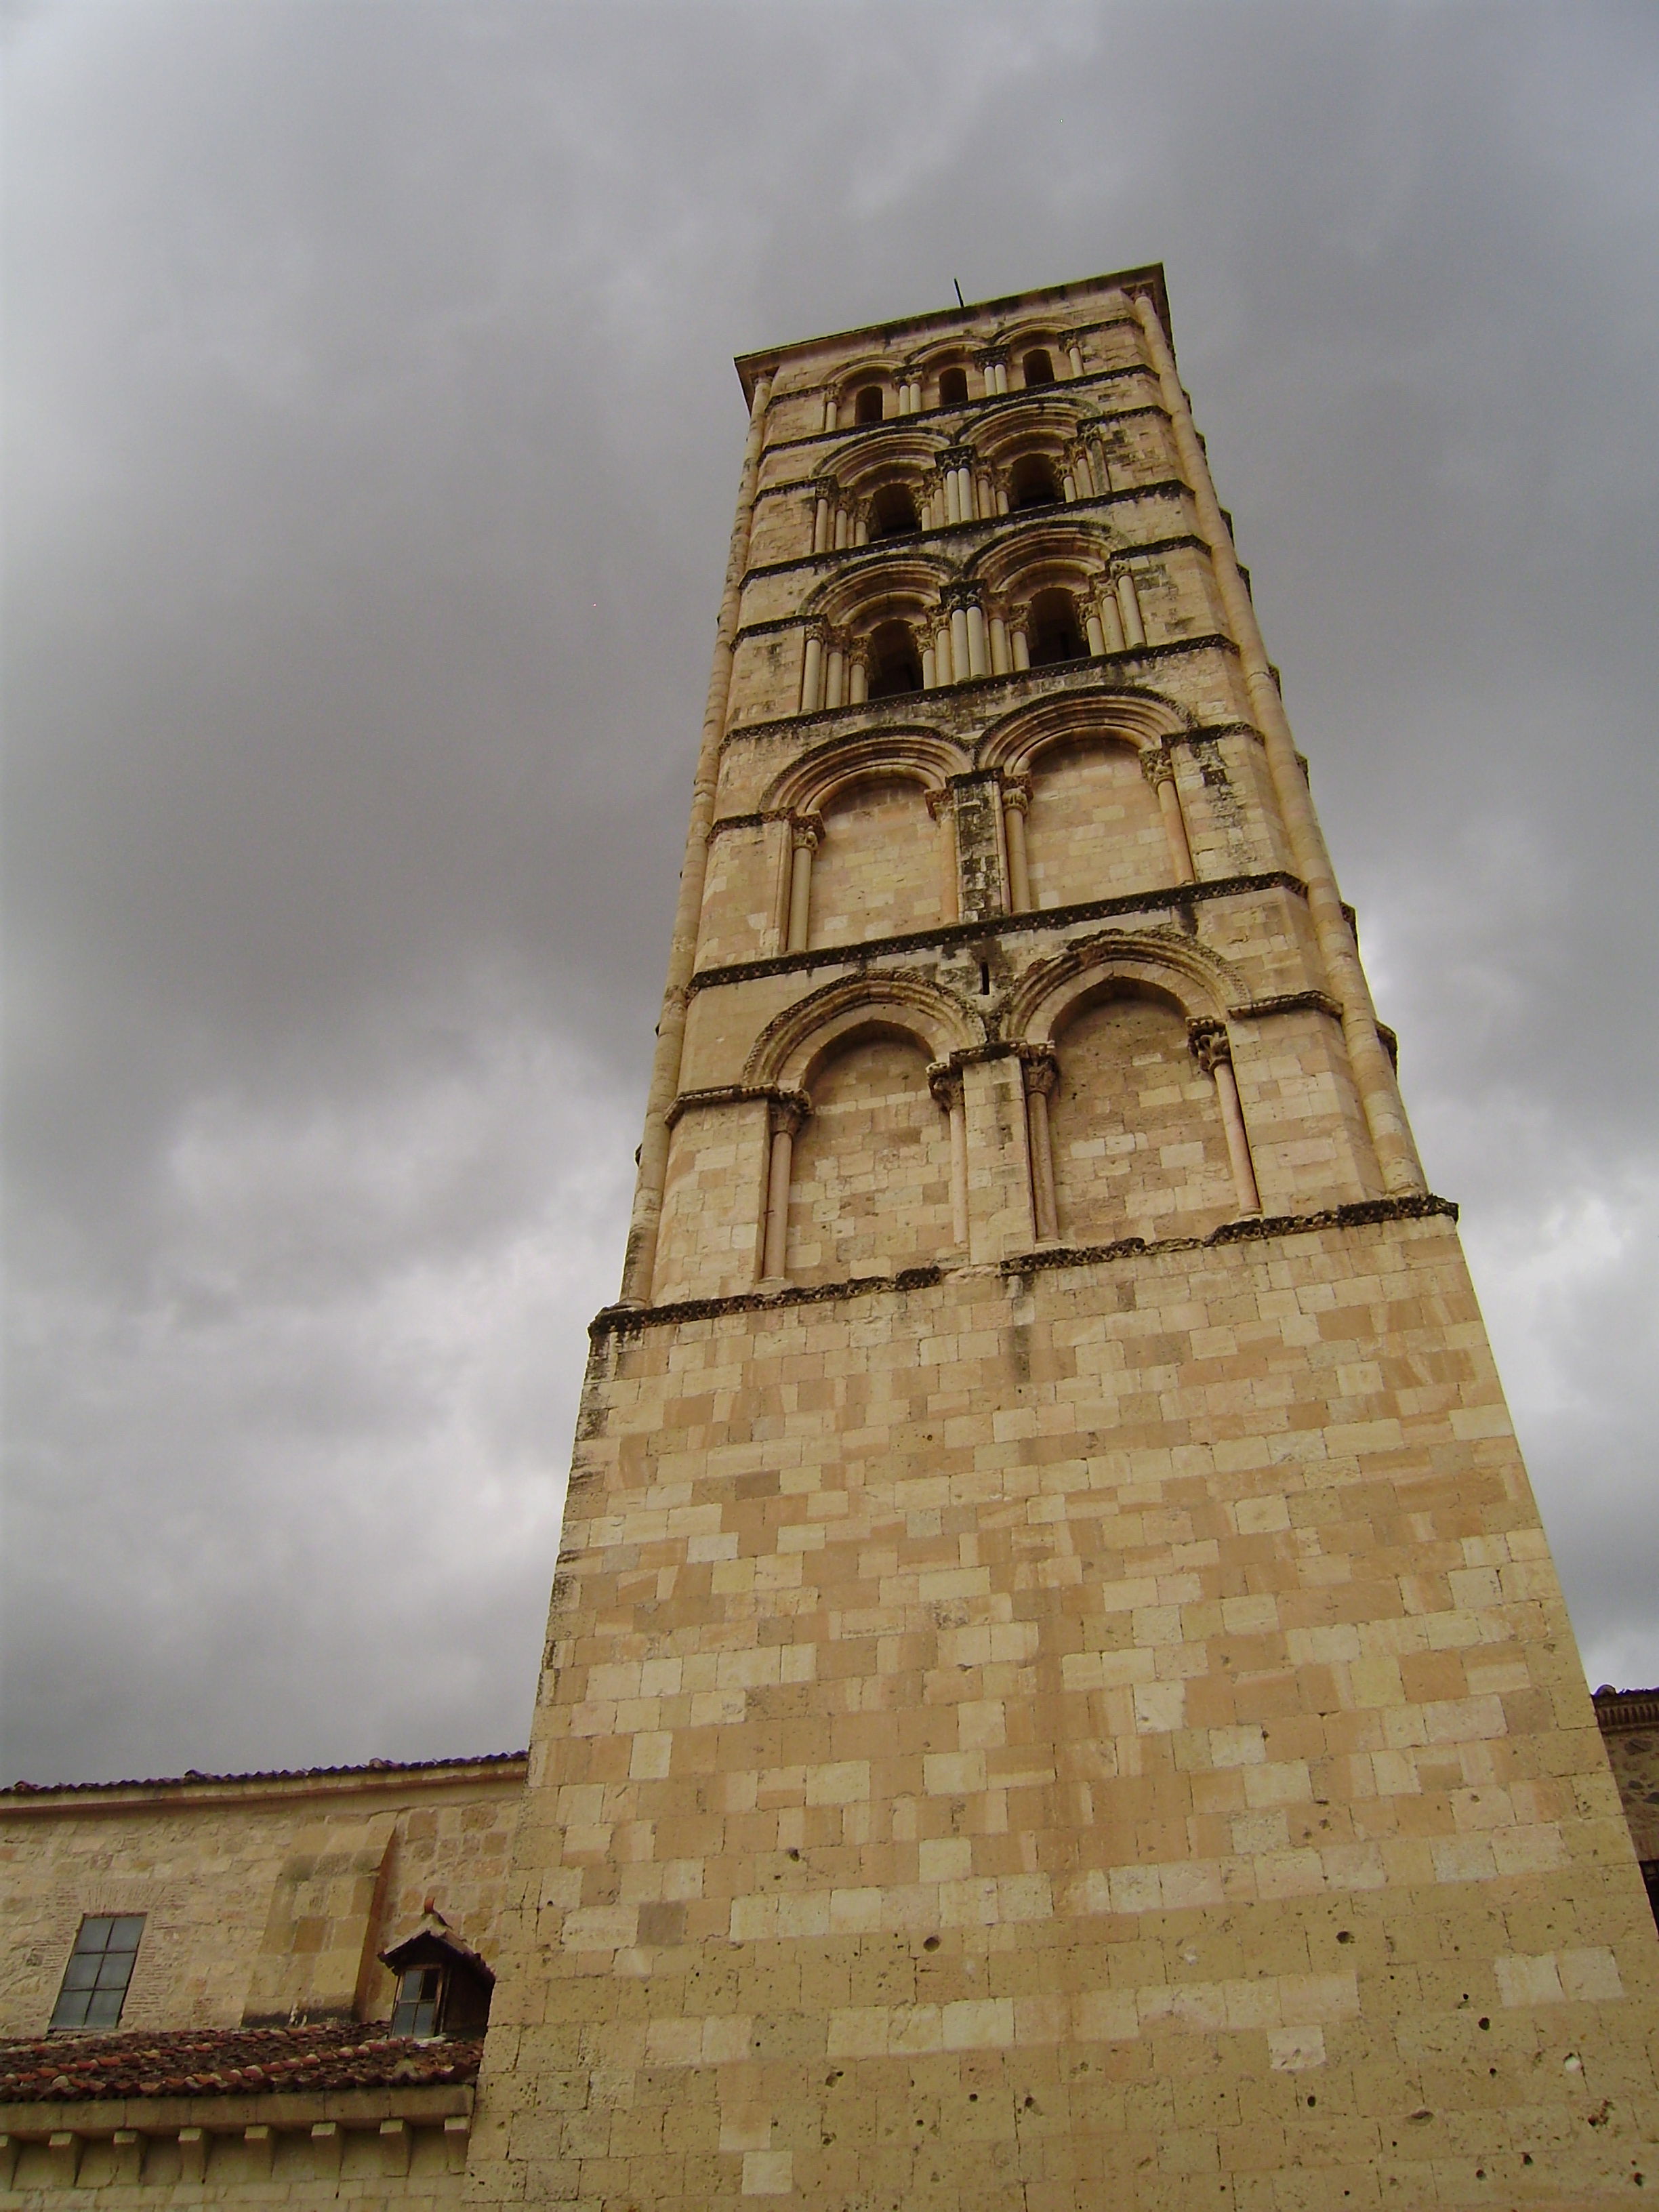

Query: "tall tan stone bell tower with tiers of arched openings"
<box><xmin>473</xmin><ymin>268</ymin><xmax>1659</xmax><ymax>2212</ymax></box>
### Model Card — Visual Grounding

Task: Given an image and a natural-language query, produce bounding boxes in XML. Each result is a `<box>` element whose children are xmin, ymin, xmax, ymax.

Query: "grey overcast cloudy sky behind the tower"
<box><xmin>0</xmin><ymin>0</ymin><xmax>1659</xmax><ymax>1781</ymax></box>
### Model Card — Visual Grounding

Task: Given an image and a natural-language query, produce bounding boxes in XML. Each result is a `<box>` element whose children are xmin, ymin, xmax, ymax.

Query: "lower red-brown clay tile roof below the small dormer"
<box><xmin>0</xmin><ymin>2020</ymin><xmax>485</xmax><ymax>2104</ymax></box>
